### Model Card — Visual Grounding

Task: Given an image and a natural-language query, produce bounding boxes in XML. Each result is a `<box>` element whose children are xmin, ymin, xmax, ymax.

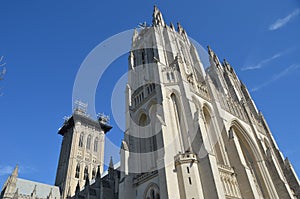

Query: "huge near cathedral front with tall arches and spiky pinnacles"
<box><xmin>119</xmin><ymin>7</ymin><xmax>300</xmax><ymax>199</ymax></box>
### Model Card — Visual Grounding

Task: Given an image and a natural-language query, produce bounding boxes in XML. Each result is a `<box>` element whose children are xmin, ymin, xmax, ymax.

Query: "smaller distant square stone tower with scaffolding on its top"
<box><xmin>55</xmin><ymin>102</ymin><xmax>112</xmax><ymax>198</ymax></box>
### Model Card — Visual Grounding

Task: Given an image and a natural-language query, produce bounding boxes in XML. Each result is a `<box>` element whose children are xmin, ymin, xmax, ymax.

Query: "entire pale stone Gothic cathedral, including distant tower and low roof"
<box><xmin>0</xmin><ymin>6</ymin><xmax>300</xmax><ymax>199</ymax></box>
